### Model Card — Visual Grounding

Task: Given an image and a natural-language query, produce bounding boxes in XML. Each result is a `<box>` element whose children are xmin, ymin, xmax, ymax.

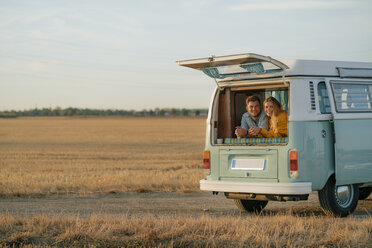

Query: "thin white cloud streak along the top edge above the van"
<box><xmin>229</xmin><ymin>1</ymin><xmax>361</xmax><ymax>11</ymax></box>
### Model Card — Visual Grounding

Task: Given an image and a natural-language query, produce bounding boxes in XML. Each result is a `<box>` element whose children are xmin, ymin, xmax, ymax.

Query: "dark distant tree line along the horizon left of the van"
<box><xmin>0</xmin><ymin>107</ymin><xmax>208</xmax><ymax>118</ymax></box>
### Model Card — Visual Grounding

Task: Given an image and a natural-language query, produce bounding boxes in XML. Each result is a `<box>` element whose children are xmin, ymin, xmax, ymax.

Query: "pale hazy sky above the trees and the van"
<box><xmin>0</xmin><ymin>0</ymin><xmax>372</xmax><ymax>110</ymax></box>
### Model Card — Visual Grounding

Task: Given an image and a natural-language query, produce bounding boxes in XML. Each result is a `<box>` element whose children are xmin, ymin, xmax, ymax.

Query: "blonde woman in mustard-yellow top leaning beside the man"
<box><xmin>249</xmin><ymin>96</ymin><xmax>288</xmax><ymax>138</ymax></box>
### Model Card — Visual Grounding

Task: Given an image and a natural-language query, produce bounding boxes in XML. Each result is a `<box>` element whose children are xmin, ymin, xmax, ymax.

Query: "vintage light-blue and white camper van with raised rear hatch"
<box><xmin>177</xmin><ymin>53</ymin><xmax>372</xmax><ymax>217</ymax></box>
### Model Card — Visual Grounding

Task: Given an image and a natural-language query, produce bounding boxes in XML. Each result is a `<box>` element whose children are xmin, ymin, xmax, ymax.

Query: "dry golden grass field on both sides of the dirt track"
<box><xmin>0</xmin><ymin>117</ymin><xmax>372</xmax><ymax>247</ymax></box>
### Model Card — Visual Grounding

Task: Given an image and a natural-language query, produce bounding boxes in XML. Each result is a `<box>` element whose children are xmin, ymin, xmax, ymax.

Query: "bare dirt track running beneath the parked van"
<box><xmin>0</xmin><ymin>192</ymin><xmax>372</xmax><ymax>218</ymax></box>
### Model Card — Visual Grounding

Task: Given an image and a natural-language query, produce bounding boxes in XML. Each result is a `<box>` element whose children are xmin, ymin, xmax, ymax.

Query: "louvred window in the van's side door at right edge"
<box><xmin>332</xmin><ymin>82</ymin><xmax>372</xmax><ymax>112</ymax></box>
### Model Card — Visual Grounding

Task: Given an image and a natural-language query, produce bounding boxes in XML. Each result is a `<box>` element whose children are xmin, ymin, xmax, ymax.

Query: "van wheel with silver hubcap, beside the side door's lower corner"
<box><xmin>318</xmin><ymin>176</ymin><xmax>359</xmax><ymax>217</ymax></box>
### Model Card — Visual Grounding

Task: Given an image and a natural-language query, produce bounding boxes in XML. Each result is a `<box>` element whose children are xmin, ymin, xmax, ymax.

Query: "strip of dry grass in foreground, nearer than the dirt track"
<box><xmin>0</xmin><ymin>214</ymin><xmax>372</xmax><ymax>247</ymax></box>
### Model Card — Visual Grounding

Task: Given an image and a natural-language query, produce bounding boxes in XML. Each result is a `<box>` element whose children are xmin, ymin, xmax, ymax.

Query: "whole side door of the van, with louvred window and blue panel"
<box><xmin>327</xmin><ymin>79</ymin><xmax>372</xmax><ymax>185</ymax></box>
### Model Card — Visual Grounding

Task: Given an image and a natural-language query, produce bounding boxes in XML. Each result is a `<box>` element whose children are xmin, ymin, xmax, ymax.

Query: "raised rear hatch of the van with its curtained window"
<box><xmin>177</xmin><ymin>53</ymin><xmax>289</xmax><ymax>87</ymax></box>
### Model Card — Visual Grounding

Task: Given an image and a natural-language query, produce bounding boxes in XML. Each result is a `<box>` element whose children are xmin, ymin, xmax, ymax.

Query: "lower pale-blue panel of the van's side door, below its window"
<box><xmin>334</xmin><ymin>119</ymin><xmax>372</xmax><ymax>185</ymax></box>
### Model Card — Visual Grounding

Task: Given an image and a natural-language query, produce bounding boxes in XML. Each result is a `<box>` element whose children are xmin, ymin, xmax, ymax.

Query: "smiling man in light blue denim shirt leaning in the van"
<box><xmin>235</xmin><ymin>96</ymin><xmax>269</xmax><ymax>138</ymax></box>
